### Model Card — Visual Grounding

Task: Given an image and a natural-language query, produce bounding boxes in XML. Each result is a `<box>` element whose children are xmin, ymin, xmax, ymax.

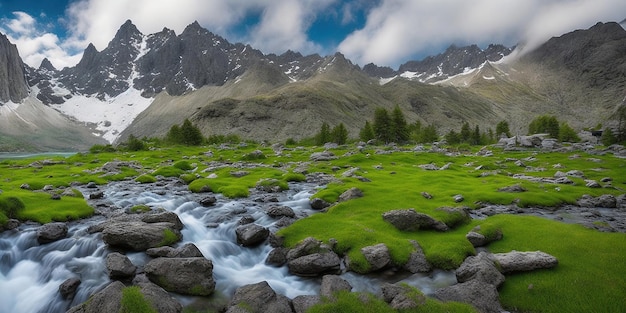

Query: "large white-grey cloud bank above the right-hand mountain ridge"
<box><xmin>338</xmin><ymin>0</ymin><xmax>626</xmax><ymax>65</ymax></box>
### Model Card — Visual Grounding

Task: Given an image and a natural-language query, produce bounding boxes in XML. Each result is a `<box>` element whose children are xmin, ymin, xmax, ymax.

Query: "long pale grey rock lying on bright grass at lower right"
<box><xmin>493</xmin><ymin>251</ymin><xmax>559</xmax><ymax>274</ymax></box>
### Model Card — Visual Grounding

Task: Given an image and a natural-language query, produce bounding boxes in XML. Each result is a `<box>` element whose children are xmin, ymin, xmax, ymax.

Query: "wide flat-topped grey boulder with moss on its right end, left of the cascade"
<box><xmin>102</xmin><ymin>222</ymin><xmax>182</xmax><ymax>251</ymax></box>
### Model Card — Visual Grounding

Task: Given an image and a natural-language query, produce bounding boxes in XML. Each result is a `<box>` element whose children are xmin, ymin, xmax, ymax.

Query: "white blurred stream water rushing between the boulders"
<box><xmin>0</xmin><ymin>182</ymin><xmax>456</xmax><ymax>313</ymax></box>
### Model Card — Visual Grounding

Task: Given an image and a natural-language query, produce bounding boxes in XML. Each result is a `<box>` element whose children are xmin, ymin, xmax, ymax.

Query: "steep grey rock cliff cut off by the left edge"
<box><xmin>0</xmin><ymin>34</ymin><xmax>28</xmax><ymax>105</ymax></box>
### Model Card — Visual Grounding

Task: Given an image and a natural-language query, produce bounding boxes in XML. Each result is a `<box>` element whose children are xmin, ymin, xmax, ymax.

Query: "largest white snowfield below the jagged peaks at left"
<box><xmin>50</xmin><ymin>88</ymin><xmax>154</xmax><ymax>143</ymax></box>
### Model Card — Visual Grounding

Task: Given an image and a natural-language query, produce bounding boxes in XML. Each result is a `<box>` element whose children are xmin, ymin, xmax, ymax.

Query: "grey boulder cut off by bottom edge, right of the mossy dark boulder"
<box><xmin>226</xmin><ymin>281</ymin><xmax>293</xmax><ymax>313</ymax></box>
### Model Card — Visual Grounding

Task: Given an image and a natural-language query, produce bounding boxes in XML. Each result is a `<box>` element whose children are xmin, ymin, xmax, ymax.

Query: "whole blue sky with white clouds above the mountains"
<box><xmin>0</xmin><ymin>0</ymin><xmax>626</xmax><ymax>68</ymax></box>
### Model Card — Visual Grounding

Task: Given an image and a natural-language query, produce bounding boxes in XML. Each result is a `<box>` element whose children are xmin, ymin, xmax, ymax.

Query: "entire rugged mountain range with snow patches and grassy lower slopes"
<box><xmin>0</xmin><ymin>21</ymin><xmax>626</xmax><ymax>151</ymax></box>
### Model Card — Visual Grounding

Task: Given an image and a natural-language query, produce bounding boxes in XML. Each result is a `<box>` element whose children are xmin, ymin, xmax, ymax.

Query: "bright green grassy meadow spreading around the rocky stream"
<box><xmin>0</xmin><ymin>143</ymin><xmax>626</xmax><ymax>312</ymax></box>
